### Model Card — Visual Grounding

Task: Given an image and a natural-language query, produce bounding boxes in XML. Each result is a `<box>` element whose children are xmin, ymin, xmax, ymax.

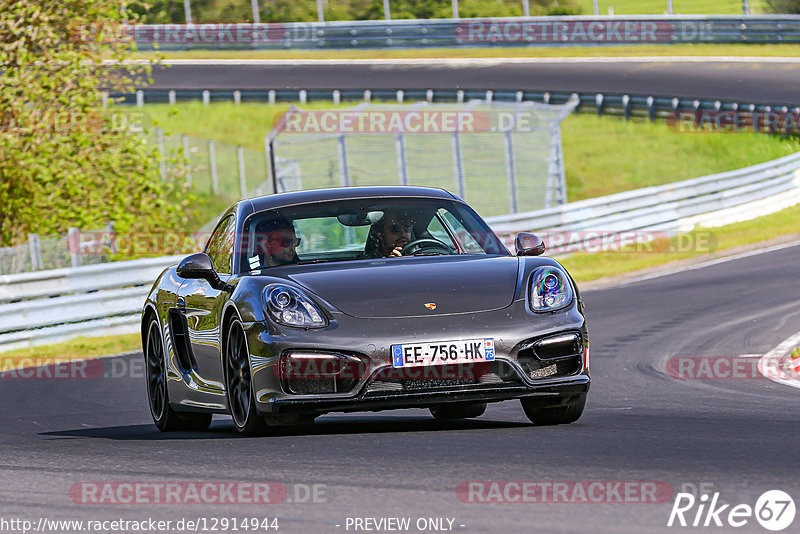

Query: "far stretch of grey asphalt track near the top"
<box><xmin>145</xmin><ymin>58</ymin><xmax>800</xmax><ymax>106</ymax></box>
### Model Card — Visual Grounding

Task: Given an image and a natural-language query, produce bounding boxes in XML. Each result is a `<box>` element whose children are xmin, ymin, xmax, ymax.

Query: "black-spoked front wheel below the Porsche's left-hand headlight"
<box><xmin>225</xmin><ymin>319</ymin><xmax>267</xmax><ymax>436</ymax></box>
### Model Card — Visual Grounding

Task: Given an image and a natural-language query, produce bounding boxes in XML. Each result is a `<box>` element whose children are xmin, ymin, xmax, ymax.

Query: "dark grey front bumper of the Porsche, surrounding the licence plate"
<box><xmin>245</xmin><ymin>302</ymin><xmax>591</xmax><ymax>416</ymax></box>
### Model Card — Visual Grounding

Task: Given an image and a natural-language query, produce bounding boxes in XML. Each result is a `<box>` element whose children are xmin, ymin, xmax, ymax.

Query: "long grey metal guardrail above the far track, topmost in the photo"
<box><xmin>123</xmin><ymin>15</ymin><xmax>800</xmax><ymax>50</ymax></box>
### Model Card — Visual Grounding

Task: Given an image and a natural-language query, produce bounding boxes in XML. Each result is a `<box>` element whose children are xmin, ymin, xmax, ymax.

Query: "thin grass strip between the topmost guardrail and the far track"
<box><xmin>138</xmin><ymin>44</ymin><xmax>800</xmax><ymax>60</ymax></box>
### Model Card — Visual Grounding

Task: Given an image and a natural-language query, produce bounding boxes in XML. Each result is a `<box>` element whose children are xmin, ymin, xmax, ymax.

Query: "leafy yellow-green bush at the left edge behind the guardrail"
<box><xmin>0</xmin><ymin>0</ymin><xmax>192</xmax><ymax>249</ymax></box>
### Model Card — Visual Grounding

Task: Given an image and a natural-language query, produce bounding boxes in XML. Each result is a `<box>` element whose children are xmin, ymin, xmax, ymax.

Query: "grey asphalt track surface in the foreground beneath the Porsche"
<box><xmin>0</xmin><ymin>245</ymin><xmax>800</xmax><ymax>534</ymax></box>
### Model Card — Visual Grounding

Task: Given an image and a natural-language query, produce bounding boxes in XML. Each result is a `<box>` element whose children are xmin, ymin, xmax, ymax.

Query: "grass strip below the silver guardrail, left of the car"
<box><xmin>0</xmin><ymin>334</ymin><xmax>142</xmax><ymax>370</ymax></box>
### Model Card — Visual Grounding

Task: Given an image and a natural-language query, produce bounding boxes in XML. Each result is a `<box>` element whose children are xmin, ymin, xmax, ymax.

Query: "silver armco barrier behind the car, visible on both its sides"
<box><xmin>0</xmin><ymin>153</ymin><xmax>800</xmax><ymax>351</ymax></box>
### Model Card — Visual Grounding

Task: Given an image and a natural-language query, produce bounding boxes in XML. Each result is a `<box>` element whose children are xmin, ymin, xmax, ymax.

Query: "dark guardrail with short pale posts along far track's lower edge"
<box><xmin>120</xmin><ymin>88</ymin><xmax>800</xmax><ymax>121</ymax></box>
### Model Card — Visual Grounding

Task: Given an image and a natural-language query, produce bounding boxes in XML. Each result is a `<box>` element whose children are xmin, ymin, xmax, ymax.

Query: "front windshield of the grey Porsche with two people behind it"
<box><xmin>240</xmin><ymin>198</ymin><xmax>509</xmax><ymax>272</ymax></box>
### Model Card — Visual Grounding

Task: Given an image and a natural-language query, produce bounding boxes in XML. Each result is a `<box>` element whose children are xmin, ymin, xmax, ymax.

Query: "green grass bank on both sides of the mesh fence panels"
<box><xmin>144</xmin><ymin>102</ymin><xmax>800</xmax><ymax>201</ymax></box>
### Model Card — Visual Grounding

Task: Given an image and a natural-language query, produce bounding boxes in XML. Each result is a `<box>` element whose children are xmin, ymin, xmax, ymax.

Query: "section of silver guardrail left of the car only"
<box><xmin>0</xmin><ymin>256</ymin><xmax>182</xmax><ymax>352</ymax></box>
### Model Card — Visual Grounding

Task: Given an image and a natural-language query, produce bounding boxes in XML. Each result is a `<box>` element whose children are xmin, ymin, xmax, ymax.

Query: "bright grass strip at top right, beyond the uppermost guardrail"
<box><xmin>577</xmin><ymin>0</ymin><xmax>766</xmax><ymax>15</ymax></box>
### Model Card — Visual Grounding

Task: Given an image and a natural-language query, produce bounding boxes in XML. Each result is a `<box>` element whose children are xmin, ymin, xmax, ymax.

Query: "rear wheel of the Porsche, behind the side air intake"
<box><xmin>144</xmin><ymin>317</ymin><xmax>212</xmax><ymax>432</ymax></box>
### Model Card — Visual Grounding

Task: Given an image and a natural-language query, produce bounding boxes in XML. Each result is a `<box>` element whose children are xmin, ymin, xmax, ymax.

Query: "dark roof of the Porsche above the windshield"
<box><xmin>243</xmin><ymin>186</ymin><xmax>456</xmax><ymax>212</ymax></box>
